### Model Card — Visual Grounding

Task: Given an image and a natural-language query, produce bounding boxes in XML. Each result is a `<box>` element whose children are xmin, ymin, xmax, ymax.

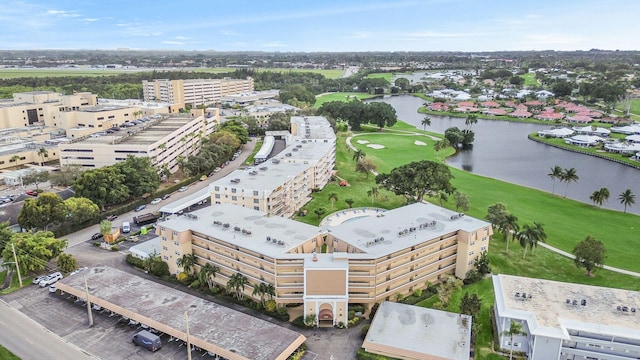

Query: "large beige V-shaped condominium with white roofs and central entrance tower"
<box><xmin>157</xmin><ymin>203</ymin><xmax>493</xmax><ymax>326</ymax></box>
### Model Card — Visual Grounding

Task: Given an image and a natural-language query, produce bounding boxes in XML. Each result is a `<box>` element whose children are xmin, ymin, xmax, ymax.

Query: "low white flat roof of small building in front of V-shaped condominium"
<box><xmin>362</xmin><ymin>301</ymin><xmax>472</xmax><ymax>360</ymax></box>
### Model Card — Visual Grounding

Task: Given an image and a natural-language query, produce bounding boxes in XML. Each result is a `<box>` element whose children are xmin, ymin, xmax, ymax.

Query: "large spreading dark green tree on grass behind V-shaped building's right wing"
<box><xmin>376</xmin><ymin>160</ymin><xmax>455</xmax><ymax>202</ymax></box>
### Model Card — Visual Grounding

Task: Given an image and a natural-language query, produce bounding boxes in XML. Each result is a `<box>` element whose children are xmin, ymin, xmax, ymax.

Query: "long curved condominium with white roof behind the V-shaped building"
<box><xmin>209</xmin><ymin>116</ymin><xmax>336</xmax><ymax>217</ymax></box>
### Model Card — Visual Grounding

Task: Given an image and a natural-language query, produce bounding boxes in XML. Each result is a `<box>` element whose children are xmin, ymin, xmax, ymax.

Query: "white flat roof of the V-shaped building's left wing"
<box><xmin>158</xmin><ymin>204</ymin><xmax>319</xmax><ymax>258</ymax></box>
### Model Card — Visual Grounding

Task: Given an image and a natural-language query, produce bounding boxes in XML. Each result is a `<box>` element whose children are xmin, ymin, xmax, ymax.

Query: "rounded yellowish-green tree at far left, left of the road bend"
<box><xmin>18</xmin><ymin>193</ymin><xmax>67</xmax><ymax>231</ymax></box>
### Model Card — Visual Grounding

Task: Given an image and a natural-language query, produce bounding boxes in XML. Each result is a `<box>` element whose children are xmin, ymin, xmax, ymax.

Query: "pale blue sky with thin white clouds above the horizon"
<box><xmin>0</xmin><ymin>0</ymin><xmax>640</xmax><ymax>52</ymax></box>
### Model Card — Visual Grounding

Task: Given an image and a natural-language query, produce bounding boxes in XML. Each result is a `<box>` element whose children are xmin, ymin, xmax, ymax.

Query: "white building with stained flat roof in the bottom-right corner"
<box><xmin>493</xmin><ymin>274</ymin><xmax>640</xmax><ymax>360</ymax></box>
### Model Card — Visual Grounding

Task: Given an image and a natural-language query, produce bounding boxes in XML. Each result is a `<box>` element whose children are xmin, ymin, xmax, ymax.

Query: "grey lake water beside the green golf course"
<box><xmin>371</xmin><ymin>95</ymin><xmax>640</xmax><ymax>214</ymax></box>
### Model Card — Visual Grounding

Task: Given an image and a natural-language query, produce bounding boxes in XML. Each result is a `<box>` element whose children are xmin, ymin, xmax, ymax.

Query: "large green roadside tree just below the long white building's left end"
<box><xmin>73</xmin><ymin>166</ymin><xmax>129</xmax><ymax>210</ymax></box>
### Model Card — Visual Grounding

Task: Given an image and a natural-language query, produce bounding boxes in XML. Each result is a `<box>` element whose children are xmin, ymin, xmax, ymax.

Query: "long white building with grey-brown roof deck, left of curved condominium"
<box><xmin>59</xmin><ymin>109</ymin><xmax>219</xmax><ymax>172</ymax></box>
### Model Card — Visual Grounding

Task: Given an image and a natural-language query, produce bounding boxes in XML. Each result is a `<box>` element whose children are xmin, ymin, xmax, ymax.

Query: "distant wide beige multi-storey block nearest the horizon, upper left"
<box><xmin>142</xmin><ymin>77</ymin><xmax>254</xmax><ymax>107</ymax></box>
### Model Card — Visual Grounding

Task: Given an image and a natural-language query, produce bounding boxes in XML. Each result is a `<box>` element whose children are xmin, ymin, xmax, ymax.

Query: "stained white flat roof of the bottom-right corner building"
<box><xmin>493</xmin><ymin>274</ymin><xmax>640</xmax><ymax>339</ymax></box>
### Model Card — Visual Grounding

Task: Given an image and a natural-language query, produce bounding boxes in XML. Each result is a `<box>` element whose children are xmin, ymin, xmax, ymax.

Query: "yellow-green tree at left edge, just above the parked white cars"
<box><xmin>2</xmin><ymin>231</ymin><xmax>67</xmax><ymax>274</ymax></box>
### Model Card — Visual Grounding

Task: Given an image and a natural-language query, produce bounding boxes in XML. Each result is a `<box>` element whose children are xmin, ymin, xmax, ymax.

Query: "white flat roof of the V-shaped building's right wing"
<box><xmin>329</xmin><ymin>203</ymin><xmax>491</xmax><ymax>257</ymax></box>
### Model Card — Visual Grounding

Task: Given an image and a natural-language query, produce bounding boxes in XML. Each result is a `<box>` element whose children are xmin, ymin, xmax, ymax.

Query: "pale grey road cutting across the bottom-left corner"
<box><xmin>0</xmin><ymin>300</ymin><xmax>98</xmax><ymax>360</ymax></box>
